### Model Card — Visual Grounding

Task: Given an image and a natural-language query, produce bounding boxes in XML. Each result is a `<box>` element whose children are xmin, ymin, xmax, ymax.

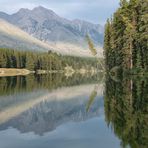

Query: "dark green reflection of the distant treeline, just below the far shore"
<box><xmin>0</xmin><ymin>73</ymin><xmax>100</xmax><ymax>96</ymax></box>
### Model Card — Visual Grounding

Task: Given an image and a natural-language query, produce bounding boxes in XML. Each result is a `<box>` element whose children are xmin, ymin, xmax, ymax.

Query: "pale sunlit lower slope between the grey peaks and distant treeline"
<box><xmin>0</xmin><ymin>19</ymin><xmax>97</xmax><ymax>57</ymax></box>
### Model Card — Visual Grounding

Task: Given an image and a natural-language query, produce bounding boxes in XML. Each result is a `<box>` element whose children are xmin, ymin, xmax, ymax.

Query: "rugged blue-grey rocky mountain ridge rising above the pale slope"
<box><xmin>0</xmin><ymin>6</ymin><xmax>103</xmax><ymax>44</ymax></box>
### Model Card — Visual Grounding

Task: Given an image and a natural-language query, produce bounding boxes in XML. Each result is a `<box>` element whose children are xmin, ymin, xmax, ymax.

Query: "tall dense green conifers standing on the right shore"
<box><xmin>104</xmin><ymin>0</ymin><xmax>148</xmax><ymax>72</ymax></box>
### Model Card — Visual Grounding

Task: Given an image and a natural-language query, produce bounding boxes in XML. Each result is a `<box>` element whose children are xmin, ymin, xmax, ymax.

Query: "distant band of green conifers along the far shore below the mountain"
<box><xmin>0</xmin><ymin>48</ymin><xmax>100</xmax><ymax>70</ymax></box>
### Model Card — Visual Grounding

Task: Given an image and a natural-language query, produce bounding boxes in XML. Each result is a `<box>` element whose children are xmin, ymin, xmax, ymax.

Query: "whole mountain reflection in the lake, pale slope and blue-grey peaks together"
<box><xmin>0</xmin><ymin>84</ymin><xmax>104</xmax><ymax>135</ymax></box>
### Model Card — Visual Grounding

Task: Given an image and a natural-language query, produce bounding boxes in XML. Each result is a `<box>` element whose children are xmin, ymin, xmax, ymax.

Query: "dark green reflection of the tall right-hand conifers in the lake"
<box><xmin>105</xmin><ymin>77</ymin><xmax>148</xmax><ymax>148</ymax></box>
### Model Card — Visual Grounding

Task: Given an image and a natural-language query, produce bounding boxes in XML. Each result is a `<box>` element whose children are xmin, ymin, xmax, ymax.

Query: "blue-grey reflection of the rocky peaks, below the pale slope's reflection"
<box><xmin>0</xmin><ymin>98</ymin><xmax>103</xmax><ymax>135</ymax></box>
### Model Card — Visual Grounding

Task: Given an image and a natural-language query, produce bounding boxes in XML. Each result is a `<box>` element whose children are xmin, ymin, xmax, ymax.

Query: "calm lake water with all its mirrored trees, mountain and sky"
<box><xmin>0</xmin><ymin>74</ymin><xmax>148</xmax><ymax>148</ymax></box>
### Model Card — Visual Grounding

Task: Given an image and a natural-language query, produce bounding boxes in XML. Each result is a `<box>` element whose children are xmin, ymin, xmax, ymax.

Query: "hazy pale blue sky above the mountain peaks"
<box><xmin>0</xmin><ymin>0</ymin><xmax>119</xmax><ymax>24</ymax></box>
